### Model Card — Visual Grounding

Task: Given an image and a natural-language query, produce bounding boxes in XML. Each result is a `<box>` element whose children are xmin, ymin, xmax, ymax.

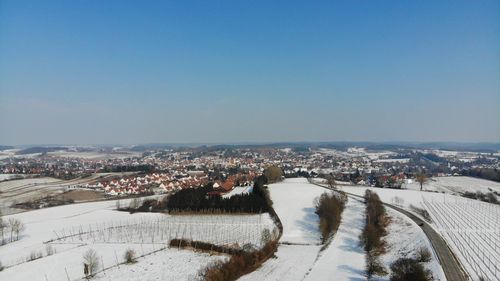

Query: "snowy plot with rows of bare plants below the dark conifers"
<box><xmin>51</xmin><ymin>213</ymin><xmax>274</xmax><ymax>247</ymax></box>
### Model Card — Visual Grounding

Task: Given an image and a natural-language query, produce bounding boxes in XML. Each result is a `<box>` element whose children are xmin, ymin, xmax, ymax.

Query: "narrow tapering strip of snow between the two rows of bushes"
<box><xmin>305</xmin><ymin>198</ymin><xmax>366</xmax><ymax>281</ymax></box>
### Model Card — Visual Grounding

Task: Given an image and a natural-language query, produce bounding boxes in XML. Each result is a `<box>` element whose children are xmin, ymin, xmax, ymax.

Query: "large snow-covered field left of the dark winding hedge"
<box><xmin>0</xmin><ymin>197</ymin><xmax>274</xmax><ymax>281</ymax></box>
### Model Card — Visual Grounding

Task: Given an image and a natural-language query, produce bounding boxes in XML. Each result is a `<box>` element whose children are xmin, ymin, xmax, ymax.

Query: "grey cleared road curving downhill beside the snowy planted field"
<box><xmin>311</xmin><ymin>179</ymin><xmax>469</xmax><ymax>281</ymax></box>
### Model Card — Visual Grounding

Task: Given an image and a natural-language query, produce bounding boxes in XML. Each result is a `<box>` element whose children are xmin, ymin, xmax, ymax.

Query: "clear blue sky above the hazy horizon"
<box><xmin>0</xmin><ymin>0</ymin><xmax>500</xmax><ymax>144</ymax></box>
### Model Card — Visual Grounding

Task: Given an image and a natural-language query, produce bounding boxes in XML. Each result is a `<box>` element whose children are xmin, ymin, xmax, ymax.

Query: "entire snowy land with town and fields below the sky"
<box><xmin>0</xmin><ymin>143</ymin><xmax>500</xmax><ymax>280</ymax></box>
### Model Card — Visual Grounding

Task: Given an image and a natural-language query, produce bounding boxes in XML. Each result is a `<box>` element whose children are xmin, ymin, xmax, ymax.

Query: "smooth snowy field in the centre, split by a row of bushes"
<box><xmin>246</xmin><ymin>178</ymin><xmax>365</xmax><ymax>280</ymax></box>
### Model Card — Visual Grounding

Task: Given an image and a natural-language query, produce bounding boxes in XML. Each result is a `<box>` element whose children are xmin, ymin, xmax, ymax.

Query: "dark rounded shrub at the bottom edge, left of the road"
<box><xmin>390</xmin><ymin>258</ymin><xmax>432</xmax><ymax>281</ymax></box>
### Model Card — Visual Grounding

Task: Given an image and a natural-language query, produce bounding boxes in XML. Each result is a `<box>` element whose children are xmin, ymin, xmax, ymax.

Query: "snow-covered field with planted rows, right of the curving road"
<box><xmin>341</xmin><ymin>184</ymin><xmax>500</xmax><ymax>280</ymax></box>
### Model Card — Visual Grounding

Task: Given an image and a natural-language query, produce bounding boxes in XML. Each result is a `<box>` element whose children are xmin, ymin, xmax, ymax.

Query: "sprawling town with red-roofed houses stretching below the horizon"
<box><xmin>0</xmin><ymin>146</ymin><xmax>500</xmax><ymax>195</ymax></box>
